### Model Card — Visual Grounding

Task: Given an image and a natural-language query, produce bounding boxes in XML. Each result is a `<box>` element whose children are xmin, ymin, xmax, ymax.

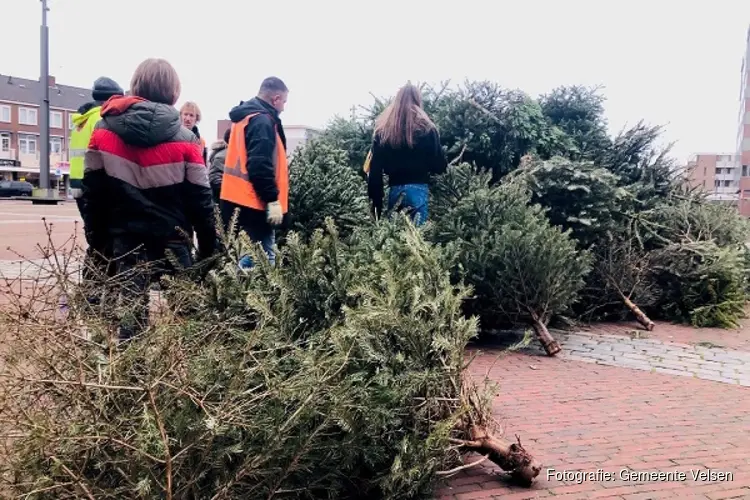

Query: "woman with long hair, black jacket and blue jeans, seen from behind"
<box><xmin>367</xmin><ymin>83</ymin><xmax>448</xmax><ymax>225</ymax></box>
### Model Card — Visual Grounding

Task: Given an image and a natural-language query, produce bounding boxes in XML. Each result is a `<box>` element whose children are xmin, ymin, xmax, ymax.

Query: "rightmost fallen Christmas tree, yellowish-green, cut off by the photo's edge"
<box><xmin>637</xmin><ymin>192</ymin><xmax>750</xmax><ymax>328</ymax></box>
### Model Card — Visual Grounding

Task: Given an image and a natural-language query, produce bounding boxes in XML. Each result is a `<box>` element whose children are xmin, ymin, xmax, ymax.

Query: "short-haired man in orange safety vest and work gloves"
<box><xmin>219</xmin><ymin>77</ymin><xmax>289</xmax><ymax>268</ymax></box>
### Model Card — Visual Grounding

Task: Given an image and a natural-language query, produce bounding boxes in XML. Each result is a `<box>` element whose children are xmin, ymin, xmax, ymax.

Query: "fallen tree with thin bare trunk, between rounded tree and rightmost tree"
<box><xmin>506</xmin><ymin>157</ymin><xmax>654</xmax><ymax>330</ymax></box>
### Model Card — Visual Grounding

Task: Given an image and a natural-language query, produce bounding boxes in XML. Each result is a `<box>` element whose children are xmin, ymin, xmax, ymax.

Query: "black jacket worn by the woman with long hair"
<box><xmin>367</xmin><ymin>129</ymin><xmax>448</xmax><ymax>212</ymax></box>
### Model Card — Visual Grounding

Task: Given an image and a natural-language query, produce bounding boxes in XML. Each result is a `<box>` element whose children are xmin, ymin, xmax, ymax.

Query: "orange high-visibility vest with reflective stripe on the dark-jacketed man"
<box><xmin>219</xmin><ymin>113</ymin><xmax>289</xmax><ymax>213</ymax></box>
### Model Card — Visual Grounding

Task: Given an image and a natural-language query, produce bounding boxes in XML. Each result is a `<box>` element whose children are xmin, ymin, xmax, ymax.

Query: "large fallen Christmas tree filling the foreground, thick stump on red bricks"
<box><xmin>0</xmin><ymin>218</ymin><xmax>540</xmax><ymax>499</ymax></box>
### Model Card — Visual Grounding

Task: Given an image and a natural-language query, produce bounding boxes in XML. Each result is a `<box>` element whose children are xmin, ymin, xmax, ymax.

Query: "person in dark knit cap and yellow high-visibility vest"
<box><xmin>69</xmin><ymin>76</ymin><xmax>124</xmax><ymax>302</ymax></box>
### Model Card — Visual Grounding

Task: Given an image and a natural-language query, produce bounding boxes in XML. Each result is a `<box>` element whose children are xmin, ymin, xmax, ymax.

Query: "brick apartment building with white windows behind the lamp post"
<box><xmin>0</xmin><ymin>74</ymin><xmax>91</xmax><ymax>185</ymax></box>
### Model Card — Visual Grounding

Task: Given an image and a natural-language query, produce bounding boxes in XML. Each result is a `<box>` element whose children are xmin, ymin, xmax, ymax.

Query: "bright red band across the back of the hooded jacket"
<box><xmin>89</xmin><ymin>128</ymin><xmax>205</xmax><ymax>167</ymax></box>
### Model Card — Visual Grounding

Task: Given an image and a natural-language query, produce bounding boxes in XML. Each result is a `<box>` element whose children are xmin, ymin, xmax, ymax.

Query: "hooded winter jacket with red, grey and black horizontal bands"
<box><xmin>83</xmin><ymin>96</ymin><xmax>216</xmax><ymax>257</ymax></box>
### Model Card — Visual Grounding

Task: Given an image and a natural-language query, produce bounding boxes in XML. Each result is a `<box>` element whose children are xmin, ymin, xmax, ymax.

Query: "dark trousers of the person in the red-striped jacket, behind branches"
<box><xmin>112</xmin><ymin>238</ymin><xmax>193</xmax><ymax>341</ymax></box>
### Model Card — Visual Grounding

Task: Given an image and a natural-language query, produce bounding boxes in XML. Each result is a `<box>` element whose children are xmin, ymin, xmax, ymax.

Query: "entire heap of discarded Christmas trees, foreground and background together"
<box><xmin>0</xmin><ymin>82</ymin><xmax>750</xmax><ymax>499</ymax></box>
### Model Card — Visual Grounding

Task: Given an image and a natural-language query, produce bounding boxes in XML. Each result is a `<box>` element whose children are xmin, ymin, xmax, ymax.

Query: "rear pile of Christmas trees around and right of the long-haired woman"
<box><xmin>312</xmin><ymin>82</ymin><xmax>750</xmax><ymax>354</ymax></box>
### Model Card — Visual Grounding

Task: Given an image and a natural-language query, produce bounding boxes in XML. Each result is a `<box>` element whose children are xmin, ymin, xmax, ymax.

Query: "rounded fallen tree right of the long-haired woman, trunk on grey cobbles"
<box><xmin>428</xmin><ymin>164</ymin><xmax>590</xmax><ymax>355</ymax></box>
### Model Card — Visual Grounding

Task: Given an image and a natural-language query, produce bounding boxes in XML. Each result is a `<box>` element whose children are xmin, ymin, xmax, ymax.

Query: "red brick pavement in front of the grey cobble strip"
<box><xmin>438</xmin><ymin>353</ymin><xmax>750</xmax><ymax>500</ymax></box>
